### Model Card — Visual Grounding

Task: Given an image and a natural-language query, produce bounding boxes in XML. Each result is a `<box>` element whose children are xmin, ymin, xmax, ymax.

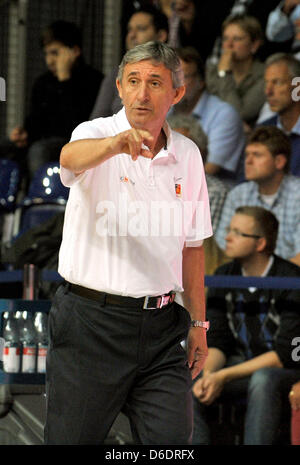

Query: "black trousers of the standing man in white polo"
<box><xmin>45</xmin><ymin>285</ymin><xmax>193</xmax><ymax>445</ymax></box>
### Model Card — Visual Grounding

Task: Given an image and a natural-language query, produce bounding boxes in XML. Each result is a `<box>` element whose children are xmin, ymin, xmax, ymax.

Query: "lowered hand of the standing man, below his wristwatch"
<box><xmin>187</xmin><ymin>327</ymin><xmax>208</xmax><ymax>379</ymax></box>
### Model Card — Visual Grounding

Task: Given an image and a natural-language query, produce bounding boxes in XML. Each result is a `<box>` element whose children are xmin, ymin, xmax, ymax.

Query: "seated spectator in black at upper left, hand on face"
<box><xmin>0</xmin><ymin>21</ymin><xmax>102</xmax><ymax>183</ymax></box>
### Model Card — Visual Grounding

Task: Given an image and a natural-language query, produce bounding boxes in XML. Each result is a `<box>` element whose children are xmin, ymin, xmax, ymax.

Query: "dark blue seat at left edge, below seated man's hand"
<box><xmin>0</xmin><ymin>158</ymin><xmax>20</xmax><ymax>213</ymax></box>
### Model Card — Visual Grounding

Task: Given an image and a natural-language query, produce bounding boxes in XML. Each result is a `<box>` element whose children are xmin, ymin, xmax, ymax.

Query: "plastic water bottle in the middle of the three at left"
<box><xmin>20</xmin><ymin>311</ymin><xmax>36</xmax><ymax>373</ymax></box>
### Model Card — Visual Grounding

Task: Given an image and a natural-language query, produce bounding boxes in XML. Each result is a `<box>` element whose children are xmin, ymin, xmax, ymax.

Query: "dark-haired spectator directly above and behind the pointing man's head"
<box><xmin>89</xmin><ymin>5</ymin><xmax>169</xmax><ymax>120</ymax></box>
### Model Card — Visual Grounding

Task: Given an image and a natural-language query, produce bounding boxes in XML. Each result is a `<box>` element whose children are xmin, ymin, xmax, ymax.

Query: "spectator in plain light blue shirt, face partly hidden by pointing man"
<box><xmin>169</xmin><ymin>47</ymin><xmax>244</xmax><ymax>184</ymax></box>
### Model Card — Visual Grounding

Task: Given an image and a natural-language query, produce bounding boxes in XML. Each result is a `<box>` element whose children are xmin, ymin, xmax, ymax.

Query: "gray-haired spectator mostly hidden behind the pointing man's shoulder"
<box><xmin>168</xmin><ymin>115</ymin><xmax>228</xmax><ymax>275</ymax></box>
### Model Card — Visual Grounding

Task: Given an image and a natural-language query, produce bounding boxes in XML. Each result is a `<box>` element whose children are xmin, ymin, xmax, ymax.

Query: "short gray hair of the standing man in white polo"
<box><xmin>118</xmin><ymin>41</ymin><xmax>184</xmax><ymax>89</ymax></box>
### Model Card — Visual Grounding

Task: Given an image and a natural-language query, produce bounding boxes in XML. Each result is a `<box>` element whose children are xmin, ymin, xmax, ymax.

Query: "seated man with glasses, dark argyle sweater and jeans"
<box><xmin>193</xmin><ymin>206</ymin><xmax>300</xmax><ymax>445</ymax></box>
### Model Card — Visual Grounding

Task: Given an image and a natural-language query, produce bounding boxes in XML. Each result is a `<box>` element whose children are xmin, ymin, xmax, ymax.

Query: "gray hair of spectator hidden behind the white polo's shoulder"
<box><xmin>167</xmin><ymin>114</ymin><xmax>208</xmax><ymax>161</ymax></box>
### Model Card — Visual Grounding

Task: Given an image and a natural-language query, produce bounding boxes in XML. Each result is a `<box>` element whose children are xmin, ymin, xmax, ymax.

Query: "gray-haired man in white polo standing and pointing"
<box><xmin>45</xmin><ymin>42</ymin><xmax>212</xmax><ymax>444</ymax></box>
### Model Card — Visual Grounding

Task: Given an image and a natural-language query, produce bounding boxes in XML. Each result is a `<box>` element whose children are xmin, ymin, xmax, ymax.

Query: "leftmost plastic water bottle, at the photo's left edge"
<box><xmin>3</xmin><ymin>312</ymin><xmax>21</xmax><ymax>373</ymax></box>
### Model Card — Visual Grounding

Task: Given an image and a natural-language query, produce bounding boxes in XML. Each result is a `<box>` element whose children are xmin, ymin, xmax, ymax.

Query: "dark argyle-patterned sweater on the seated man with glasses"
<box><xmin>207</xmin><ymin>255</ymin><xmax>300</xmax><ymax>369</ymax></box>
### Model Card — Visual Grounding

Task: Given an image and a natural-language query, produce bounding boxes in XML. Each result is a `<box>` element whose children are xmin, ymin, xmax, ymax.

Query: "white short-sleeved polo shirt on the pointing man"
<box><xmin>58</xmin><ymin>108</ymin><xmax>212</xmax><ymax>297</ymax></box>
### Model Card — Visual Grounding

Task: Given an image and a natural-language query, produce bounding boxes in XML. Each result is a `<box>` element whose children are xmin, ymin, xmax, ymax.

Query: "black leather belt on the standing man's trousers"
<box><xmin>66</xmin><ymin>282</ymin><xmax>176</xmax><ymax>310</ymax></box>
